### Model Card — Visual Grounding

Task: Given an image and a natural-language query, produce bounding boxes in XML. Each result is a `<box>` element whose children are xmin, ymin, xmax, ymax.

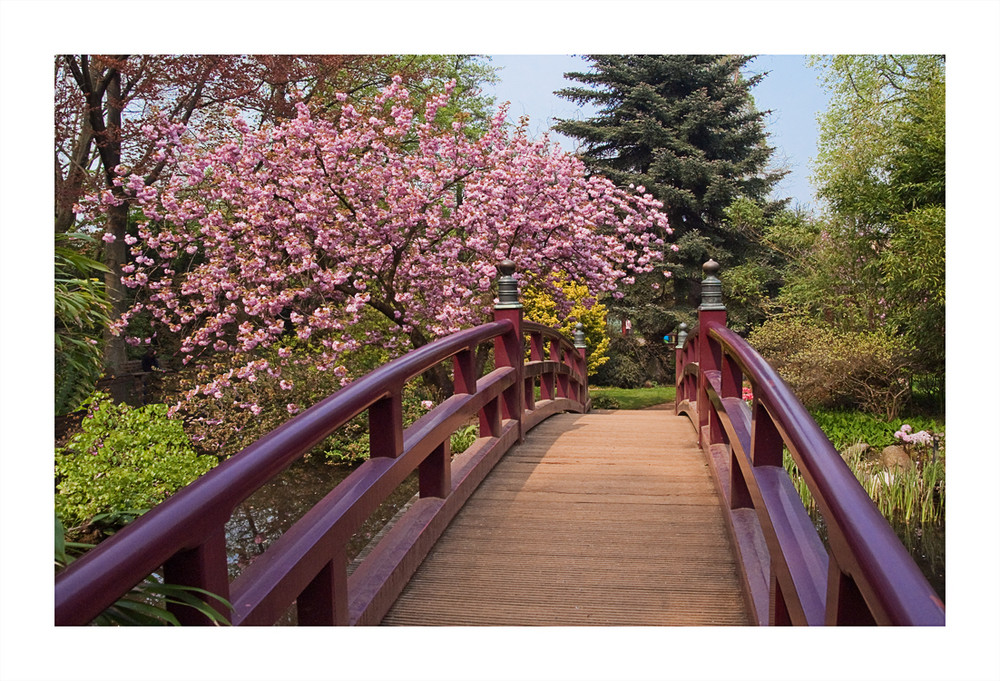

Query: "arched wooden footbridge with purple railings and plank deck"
<box><xmin>55</xmin><ymin>262</ymin><xmax>944</xmax><ymax>626</ymax></box>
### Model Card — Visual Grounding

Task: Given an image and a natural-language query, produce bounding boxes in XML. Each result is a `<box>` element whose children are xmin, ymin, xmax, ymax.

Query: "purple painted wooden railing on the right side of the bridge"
<box><xmin>676</xmin><ymin>261</ymin><xmax>945</xmax><ymax>625</ymax></box>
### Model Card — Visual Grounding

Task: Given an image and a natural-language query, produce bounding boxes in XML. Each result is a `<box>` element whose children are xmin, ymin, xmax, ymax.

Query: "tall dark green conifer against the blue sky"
<box><xmin>555</xmin><ymin>55</ymin><xmax>784</xmax><ymax>378</ymax></box>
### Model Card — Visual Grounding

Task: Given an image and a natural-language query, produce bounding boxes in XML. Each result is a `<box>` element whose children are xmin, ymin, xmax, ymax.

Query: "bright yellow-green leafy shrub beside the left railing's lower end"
<box><xmin>55</xmin><ymin>393</ymin><xmax>217</xmax><ymax>526</ymax></box>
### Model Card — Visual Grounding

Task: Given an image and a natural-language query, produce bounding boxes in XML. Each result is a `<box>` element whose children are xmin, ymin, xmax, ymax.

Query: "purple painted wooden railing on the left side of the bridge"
<box><xmin>55</xmin><ymin>261</ymin><xmax>590</xmax><ymax>625</ymax></box>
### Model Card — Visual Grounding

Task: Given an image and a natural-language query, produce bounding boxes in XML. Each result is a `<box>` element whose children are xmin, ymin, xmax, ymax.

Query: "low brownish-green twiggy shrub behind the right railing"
<box><xmin>747</xmin><ymin>316</ymin><xmax>913</xmax><ymax>419</ymax></box>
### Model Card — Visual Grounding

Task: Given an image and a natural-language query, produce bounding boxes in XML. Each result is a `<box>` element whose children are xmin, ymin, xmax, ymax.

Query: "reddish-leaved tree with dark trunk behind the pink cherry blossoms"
<box><xmin>54</xmin><ymin>54</ymin><xmax>485</xmax><ymax>371</ymax></box>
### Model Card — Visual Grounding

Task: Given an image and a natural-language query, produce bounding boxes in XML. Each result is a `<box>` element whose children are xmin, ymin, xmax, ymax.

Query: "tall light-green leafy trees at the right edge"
<box><xmin>808</xmin><ymin>55</ymin><xmax>945</xmax><ymax>380</ymax></box>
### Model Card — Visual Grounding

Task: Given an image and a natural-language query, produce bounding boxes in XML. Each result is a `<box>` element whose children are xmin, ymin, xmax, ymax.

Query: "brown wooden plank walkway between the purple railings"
<box><xmin>382</xmin><ymin>411</ymin><xmax>750</xmax><ymax>626</ymax></box>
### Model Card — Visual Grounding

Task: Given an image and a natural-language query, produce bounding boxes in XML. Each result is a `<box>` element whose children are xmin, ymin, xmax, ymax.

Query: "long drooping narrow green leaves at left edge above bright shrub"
<box><xmin>55</xmin><ymin>233</ymin><xmax>110</xmax><ymax>415</ymax></box>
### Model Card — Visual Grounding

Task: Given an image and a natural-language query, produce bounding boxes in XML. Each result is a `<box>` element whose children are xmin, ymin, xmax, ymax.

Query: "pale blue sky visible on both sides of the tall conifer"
<box><xmin>485</xmin><ymin>55</ymin><xmax>828</xmax><ymax>209</ymax></box>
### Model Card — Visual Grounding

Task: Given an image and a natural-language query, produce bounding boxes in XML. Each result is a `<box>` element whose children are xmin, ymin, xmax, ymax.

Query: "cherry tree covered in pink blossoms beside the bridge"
<box><xmin>82</xmin><ymin>77</ymin><xmax>670</xmax><ymax>406</ymax></box>
